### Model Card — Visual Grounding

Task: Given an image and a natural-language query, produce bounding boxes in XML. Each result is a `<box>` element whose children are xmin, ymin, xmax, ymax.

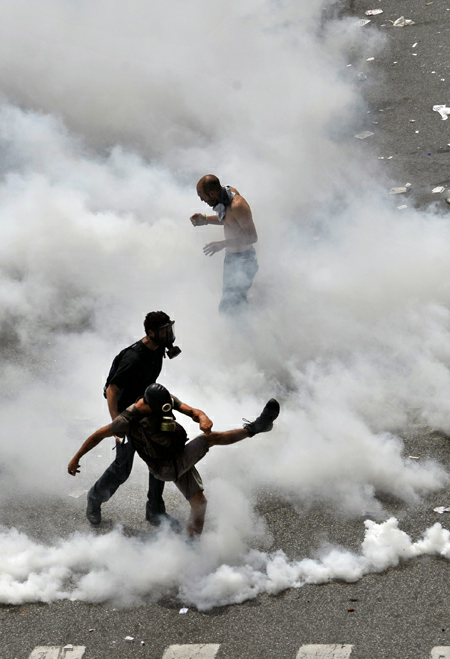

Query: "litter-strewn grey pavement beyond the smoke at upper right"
<box><xmin>348</xmin><ymin>0</ymin><xmax>450</xmax><ymax>206</ymax></box>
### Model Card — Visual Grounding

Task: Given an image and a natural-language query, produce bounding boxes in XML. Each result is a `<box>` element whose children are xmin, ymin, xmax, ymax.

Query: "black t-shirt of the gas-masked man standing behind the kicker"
<box><xmin>109</xmin><ymin>340</ymin><xmax>164</xmax><ymax>414</ymax></box>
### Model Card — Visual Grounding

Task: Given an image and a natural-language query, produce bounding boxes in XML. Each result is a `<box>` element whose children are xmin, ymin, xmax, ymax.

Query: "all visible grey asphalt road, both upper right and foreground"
<box><xmin>0</xmin><ymin>0</ymin><xmax>450</xmax><ymax>659</ymax></box>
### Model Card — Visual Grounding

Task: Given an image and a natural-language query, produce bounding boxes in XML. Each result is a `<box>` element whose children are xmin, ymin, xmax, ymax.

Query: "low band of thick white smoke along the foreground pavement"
<box><xmin>0</xmin><ymin>517</ymin><xmax>450</xmax><ymax>611</ymax></box>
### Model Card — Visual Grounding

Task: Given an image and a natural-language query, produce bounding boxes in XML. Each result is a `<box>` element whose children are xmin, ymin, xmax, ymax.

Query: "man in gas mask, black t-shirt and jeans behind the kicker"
<box><xmin>86</xmin><ymin>311</ymin><xmax>181</xmax><ymax>526</ymax></box>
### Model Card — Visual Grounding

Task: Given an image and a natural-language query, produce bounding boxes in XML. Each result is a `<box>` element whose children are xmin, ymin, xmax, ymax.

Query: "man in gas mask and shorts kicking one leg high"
<box><xmin>68</xmin><ymin>383</ymin><xmax>280</xmax><ymax>537</ymax></box>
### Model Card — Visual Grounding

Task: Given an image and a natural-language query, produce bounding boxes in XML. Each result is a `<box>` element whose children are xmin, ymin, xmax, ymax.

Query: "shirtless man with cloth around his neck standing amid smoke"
<box><xmin>191</xmin><ymin>174</ymin><xmax>258</xmax><ymax>314</ymax></box>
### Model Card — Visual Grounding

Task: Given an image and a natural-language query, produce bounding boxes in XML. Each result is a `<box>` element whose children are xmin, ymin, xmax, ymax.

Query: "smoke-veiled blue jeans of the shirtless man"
<box><xmin>219</xmin><ymin>247</ymin><xmax>258</xmax><ymax>314</ymax></box>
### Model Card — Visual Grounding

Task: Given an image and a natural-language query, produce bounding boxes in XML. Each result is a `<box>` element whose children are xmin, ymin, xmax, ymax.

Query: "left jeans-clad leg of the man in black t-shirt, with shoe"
<box><xmin>86</xmin><ymin>442</ymin><xmax>135</xmax><ymax>526</ymax></box>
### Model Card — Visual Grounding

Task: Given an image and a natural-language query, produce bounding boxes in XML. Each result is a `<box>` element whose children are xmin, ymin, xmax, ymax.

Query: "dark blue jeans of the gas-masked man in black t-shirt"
<box><xmin>88</xmin><ymin>441</ymin><xmax>166</xmax><ymax>517</ymax></box>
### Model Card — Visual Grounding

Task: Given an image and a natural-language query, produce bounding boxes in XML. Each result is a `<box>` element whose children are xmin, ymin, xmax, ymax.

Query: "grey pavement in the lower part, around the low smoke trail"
<box><xmin>0</xmin><ymin>426</ymin><xmax>450</xmax><ymax>659</ymax></box>
